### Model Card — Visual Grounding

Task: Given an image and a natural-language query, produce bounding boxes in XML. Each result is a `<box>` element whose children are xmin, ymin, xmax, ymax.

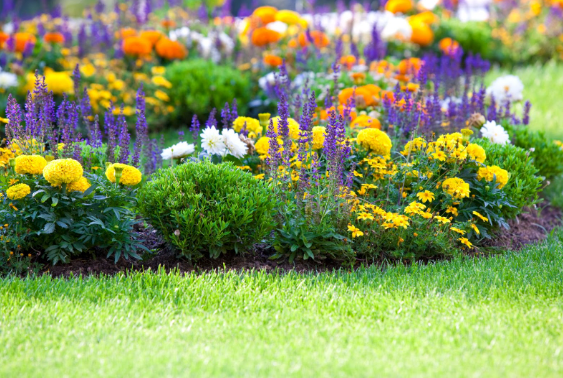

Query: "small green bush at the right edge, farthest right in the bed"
<box><xmin>503</xmin><ymin>124</ymin><xmax>563</xmax><ymax>181</ymax></box>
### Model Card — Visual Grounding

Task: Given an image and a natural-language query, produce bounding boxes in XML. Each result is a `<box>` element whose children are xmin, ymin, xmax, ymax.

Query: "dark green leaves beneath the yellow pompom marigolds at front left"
<box><xmin>0</xmin><ymin>163</ymin><xmax>146</xmax><ymax>264</ymax></box>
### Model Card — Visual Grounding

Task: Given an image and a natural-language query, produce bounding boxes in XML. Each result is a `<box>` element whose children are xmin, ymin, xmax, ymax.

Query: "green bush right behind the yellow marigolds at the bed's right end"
<box><xmin>475</xmin><ymin>139</ymin><xmax>543</xmax><ymax>219</ymax></box>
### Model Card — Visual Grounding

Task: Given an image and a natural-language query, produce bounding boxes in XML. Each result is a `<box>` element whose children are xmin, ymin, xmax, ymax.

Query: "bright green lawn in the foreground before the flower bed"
<box><xmin>0</xmin><ymin>232</ymin><xmax>563</xmax><ymax>377</ymax></box>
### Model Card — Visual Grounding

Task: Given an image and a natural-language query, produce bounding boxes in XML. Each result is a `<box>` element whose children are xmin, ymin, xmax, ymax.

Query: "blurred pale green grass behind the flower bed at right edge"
<box><xmin>486</xmin><ymin>62</ymin><xmax>563</xmax><ymax>140</ymax></box>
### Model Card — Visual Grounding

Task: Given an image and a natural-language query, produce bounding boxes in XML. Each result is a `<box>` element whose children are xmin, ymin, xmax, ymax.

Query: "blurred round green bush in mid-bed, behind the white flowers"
<box><xmin>166</xmin><ymin>59</ymin><xmax>252</xmax><ymax>123</ymax></box>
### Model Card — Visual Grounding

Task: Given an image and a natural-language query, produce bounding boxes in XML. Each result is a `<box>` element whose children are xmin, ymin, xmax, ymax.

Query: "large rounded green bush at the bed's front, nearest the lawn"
<box><xmin>138</xmin><ymin>161</ymin><xmax>275</xmax><ymax>258</ymax></box>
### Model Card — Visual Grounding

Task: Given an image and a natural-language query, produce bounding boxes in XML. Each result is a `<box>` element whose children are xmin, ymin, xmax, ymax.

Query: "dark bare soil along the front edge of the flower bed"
<box><xmin>42</xmin><ymin>203</ymin><xmax>563</xmax><ymax>277</ymax></box>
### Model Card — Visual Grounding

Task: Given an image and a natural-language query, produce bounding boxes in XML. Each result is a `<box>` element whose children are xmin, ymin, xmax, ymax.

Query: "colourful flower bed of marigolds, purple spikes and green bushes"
<box><xmin>0</xmin><ymin>1</ymin><xmax>563</xmax><ymax>273</ymax></box>
